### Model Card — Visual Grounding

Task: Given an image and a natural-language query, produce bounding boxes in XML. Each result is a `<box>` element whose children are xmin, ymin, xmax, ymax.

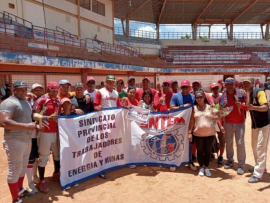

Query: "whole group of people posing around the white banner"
<box><xmin>0</xmin><ymin>75</ymin><xmax>270</xmax><ymax>202</ymax></box>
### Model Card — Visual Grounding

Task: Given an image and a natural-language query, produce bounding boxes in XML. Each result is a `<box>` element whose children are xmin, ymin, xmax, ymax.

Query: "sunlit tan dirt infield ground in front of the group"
<box><xmin>0</xmin><ymin>114</ymin><xmax>270</xmax><ymax>203</ymax></box>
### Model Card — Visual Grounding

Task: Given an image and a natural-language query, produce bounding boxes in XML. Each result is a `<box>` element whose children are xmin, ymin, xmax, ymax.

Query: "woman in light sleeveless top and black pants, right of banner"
<box><xmin>189</xmin><ymin>90</ymin><xmax>219</xmax><ymax>177</ymax></box>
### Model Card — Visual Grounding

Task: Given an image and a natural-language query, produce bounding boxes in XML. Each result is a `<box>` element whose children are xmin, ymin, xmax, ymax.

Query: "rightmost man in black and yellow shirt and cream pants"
<box><xmin>243</xmin><ymin>79</ymin><xmax>270</xmax><ymax>183</ymax></box>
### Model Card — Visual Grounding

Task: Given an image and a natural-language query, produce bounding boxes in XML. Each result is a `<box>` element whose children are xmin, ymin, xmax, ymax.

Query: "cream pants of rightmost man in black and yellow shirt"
<box><xmin>251</xmin><ymin>125</ymin><xmax>270</xmax><ymax>178</ymax></box>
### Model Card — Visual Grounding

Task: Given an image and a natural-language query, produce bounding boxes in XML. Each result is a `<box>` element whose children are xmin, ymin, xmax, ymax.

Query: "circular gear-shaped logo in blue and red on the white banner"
<box><xmin>141</xmin><ymin>127</ymin><xmax>184</xmax><ymax>161</ymax></box>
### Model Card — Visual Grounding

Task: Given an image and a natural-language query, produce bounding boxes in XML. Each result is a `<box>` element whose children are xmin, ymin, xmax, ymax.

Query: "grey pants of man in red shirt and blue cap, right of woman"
<box><xmin>224</xmin><ymin>122</ymin><xmax>246</xmax><ymax>169</ymax></box>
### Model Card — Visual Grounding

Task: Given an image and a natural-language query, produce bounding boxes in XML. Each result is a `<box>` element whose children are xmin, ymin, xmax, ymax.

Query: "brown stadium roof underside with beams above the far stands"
<box><xmin>112</xmin><ymin>0</ymin><xmax>270</xmax><ymax>24</ymax></box>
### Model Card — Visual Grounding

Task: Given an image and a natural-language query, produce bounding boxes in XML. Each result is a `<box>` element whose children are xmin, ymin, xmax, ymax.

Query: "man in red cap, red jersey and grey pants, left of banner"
<box><xmin>33</xmin><ymin>82</ymin><xmax>60</xmax><ymax>193</ymax></box>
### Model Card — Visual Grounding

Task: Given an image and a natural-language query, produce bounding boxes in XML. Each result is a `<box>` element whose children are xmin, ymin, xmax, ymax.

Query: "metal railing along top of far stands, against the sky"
<box><xmin>114</xmin><ymin>27</ymin><xmax>263</xmax><ymax>39</ymax></box>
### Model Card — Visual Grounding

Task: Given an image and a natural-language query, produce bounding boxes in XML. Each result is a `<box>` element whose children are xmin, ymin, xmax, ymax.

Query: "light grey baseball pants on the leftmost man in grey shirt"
<box><xmin>3</xmin><ymin>138</ymin><xmax>31</xmax><ymax>183</ymax></box>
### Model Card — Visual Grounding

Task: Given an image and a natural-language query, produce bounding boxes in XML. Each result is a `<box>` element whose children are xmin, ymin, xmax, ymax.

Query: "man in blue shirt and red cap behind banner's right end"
<box><xmin>170</xmin><ymin>79</ymin><xmax>197</xmax><ymax>171</ymax></box>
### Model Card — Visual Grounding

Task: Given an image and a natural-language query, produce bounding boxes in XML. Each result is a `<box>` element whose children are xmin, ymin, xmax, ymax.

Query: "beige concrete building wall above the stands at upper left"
<box><xmin>0</xmin><ymin>0</ymin><xmax>114</xmax><ymax>43</ymax></box>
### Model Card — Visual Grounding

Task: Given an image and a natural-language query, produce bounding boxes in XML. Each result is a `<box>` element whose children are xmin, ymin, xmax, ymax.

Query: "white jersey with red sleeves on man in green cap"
<box><xmin>94</xmin><ymin>87</ymin><xmax>121</xmax><ymax>110</ymax></box>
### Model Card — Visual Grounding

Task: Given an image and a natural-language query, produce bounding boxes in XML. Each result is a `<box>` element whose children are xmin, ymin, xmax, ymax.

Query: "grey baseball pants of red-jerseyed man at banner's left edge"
<box><xmin>38</xmin><ymin>133</ymin><xmax>60</xmax><ymax>167</ymax></box>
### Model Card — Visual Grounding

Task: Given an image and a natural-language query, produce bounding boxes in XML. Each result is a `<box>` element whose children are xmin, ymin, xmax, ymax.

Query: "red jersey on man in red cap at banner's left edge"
<box><xmin>36</xmin><ymin>96</ymin><xmax>60</xmax><ymax>133</ymax></box>
